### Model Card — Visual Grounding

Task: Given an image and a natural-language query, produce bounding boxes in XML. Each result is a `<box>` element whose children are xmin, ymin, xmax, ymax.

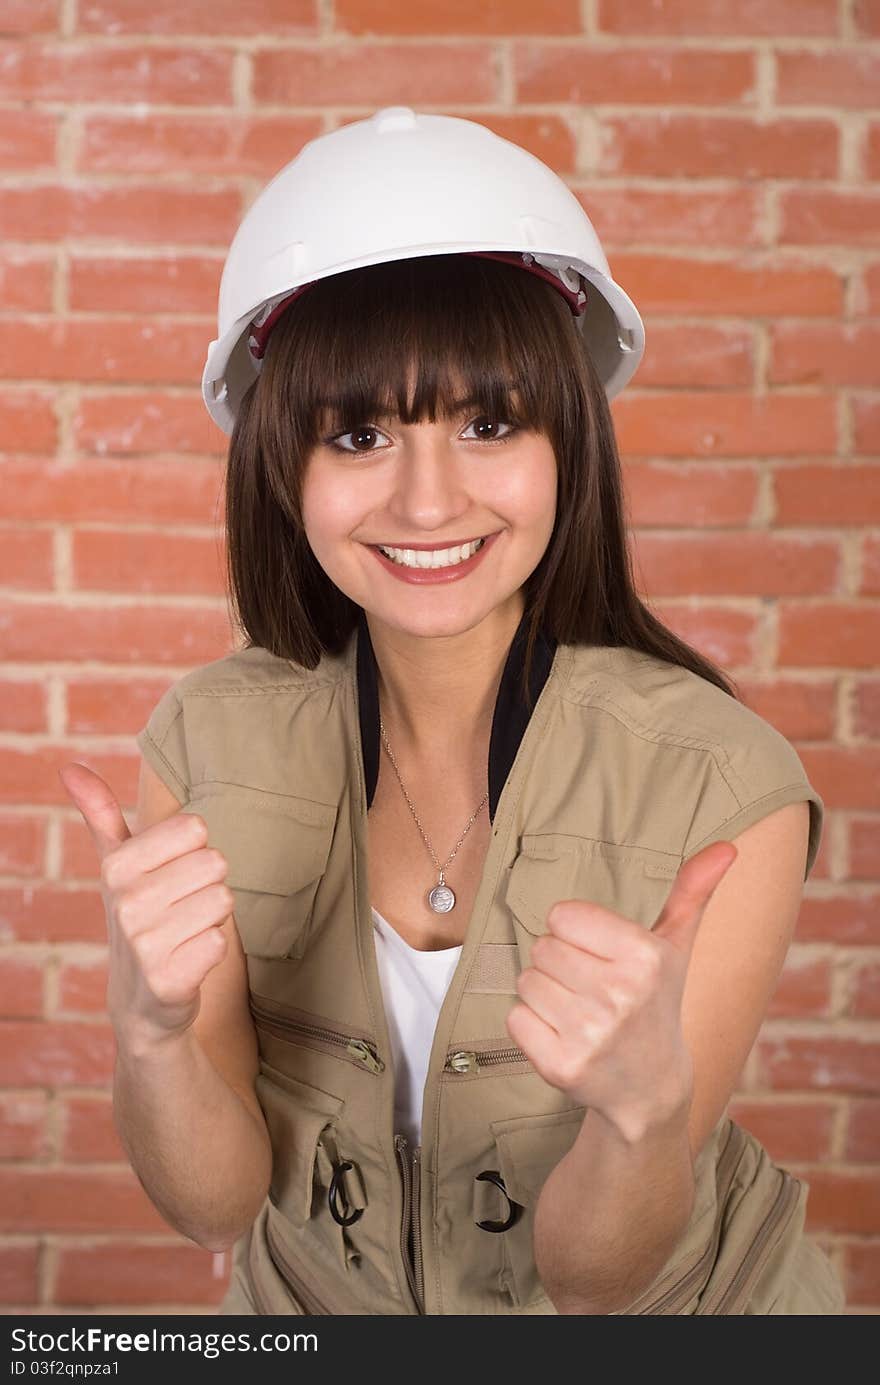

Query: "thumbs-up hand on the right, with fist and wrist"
<box><xmin>507</xmin><ymin>842</ymin><xmax>737</xmax><ymax>1141</ymax></box>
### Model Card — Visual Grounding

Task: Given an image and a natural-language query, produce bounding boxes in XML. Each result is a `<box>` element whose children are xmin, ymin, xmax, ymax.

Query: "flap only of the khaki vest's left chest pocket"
<box><xmin>184</xmin><ymin>783</ymin><xmax>337</xmax><ymax>895</ymax></box>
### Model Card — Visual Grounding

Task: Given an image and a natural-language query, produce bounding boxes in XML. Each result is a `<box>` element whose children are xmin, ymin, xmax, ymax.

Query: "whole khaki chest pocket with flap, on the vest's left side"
<box><xmin>184</xmin><ymin>781</ymin><xmax>337</xmax><ymax>957</ymax></box>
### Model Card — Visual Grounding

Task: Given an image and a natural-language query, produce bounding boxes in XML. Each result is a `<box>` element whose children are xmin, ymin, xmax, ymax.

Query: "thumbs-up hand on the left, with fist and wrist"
<box><xmin>58</xmin><ymin>762</ymin><xmax>234</xmax><ymax>1053</ymax></box>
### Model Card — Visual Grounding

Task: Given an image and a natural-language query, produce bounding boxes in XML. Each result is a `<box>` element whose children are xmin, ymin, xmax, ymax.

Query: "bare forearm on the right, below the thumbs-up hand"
<box><xmin>534</xmin><ymin>1098</ymin><xmax>694</xmax><ymax>1314</ymax></box>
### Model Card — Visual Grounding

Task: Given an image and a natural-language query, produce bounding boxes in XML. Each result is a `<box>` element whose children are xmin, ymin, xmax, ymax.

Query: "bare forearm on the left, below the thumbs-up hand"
<box><xmin>114</xmin><ymin>1029</ymin><xmax>272</xmax><ymax>1251</ymax></box>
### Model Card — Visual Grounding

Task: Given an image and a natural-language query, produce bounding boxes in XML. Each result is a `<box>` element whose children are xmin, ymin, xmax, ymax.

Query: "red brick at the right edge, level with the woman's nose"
<box><xmin>772</xmin><ymin>461</ymin><xmax>880</xmax><ymax>526</ymax></box>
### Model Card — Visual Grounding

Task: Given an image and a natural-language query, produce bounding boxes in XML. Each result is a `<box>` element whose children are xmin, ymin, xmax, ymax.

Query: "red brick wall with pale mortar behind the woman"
<box><xmin>0</xmin><ymin>0</ymin><xmax>880</xmax><ymax>1313</ymax></box>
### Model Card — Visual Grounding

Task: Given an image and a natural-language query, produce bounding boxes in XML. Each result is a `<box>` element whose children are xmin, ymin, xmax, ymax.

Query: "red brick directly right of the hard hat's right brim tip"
<box><xmin>629</xmin><ymin>324</ymin><xmax>754</xmax><ymax>389</ymax></box>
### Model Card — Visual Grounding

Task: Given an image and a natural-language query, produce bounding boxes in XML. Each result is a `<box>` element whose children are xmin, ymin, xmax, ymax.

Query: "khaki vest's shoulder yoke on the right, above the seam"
<box><xmin>563</xmin><ymin>645</ymin><xmax>804</xmax><ymax>787</ymax></box>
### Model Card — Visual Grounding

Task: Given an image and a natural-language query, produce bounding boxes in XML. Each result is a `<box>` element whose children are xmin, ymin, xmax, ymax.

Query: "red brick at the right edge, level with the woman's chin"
<box><xmin>777</xmin><ymin>614</ymin><xmax>880</xmax><ymax>669</ymax></box>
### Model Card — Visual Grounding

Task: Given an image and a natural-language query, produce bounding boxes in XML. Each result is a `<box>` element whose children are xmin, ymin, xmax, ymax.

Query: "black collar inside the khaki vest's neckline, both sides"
<box><xmin>356</xmin><ymin>608</ymin><xmax>556</xmax><ymax>821</ymax></box>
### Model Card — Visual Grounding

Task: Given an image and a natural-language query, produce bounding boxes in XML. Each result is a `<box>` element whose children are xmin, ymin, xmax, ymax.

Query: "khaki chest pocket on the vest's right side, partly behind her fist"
<box><xmin>504</xmin><ymin>832</ymin><xmax>680</xmax><ymax>968</ymax></box>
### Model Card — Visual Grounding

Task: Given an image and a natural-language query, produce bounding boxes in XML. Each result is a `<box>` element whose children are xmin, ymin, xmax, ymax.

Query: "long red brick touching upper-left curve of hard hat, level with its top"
<box><xmin>76</xmin><ymin>112</ymin><xmax>323</xmax><ymax>183</ymax></box>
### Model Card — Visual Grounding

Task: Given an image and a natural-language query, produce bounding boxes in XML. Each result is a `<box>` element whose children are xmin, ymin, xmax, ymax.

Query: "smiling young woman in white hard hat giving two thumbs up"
<box><xmin>65</xmin><ymin>108</ymin><xmax>843</xmax><ymax>1314</ymax></box>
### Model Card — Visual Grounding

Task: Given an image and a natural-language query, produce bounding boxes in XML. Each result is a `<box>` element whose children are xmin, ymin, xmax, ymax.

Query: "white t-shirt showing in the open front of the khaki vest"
<box><xmin>373</xmin><ymin>909</ymin><xmax>461</xmax><ymax>1148</ymax></box>
